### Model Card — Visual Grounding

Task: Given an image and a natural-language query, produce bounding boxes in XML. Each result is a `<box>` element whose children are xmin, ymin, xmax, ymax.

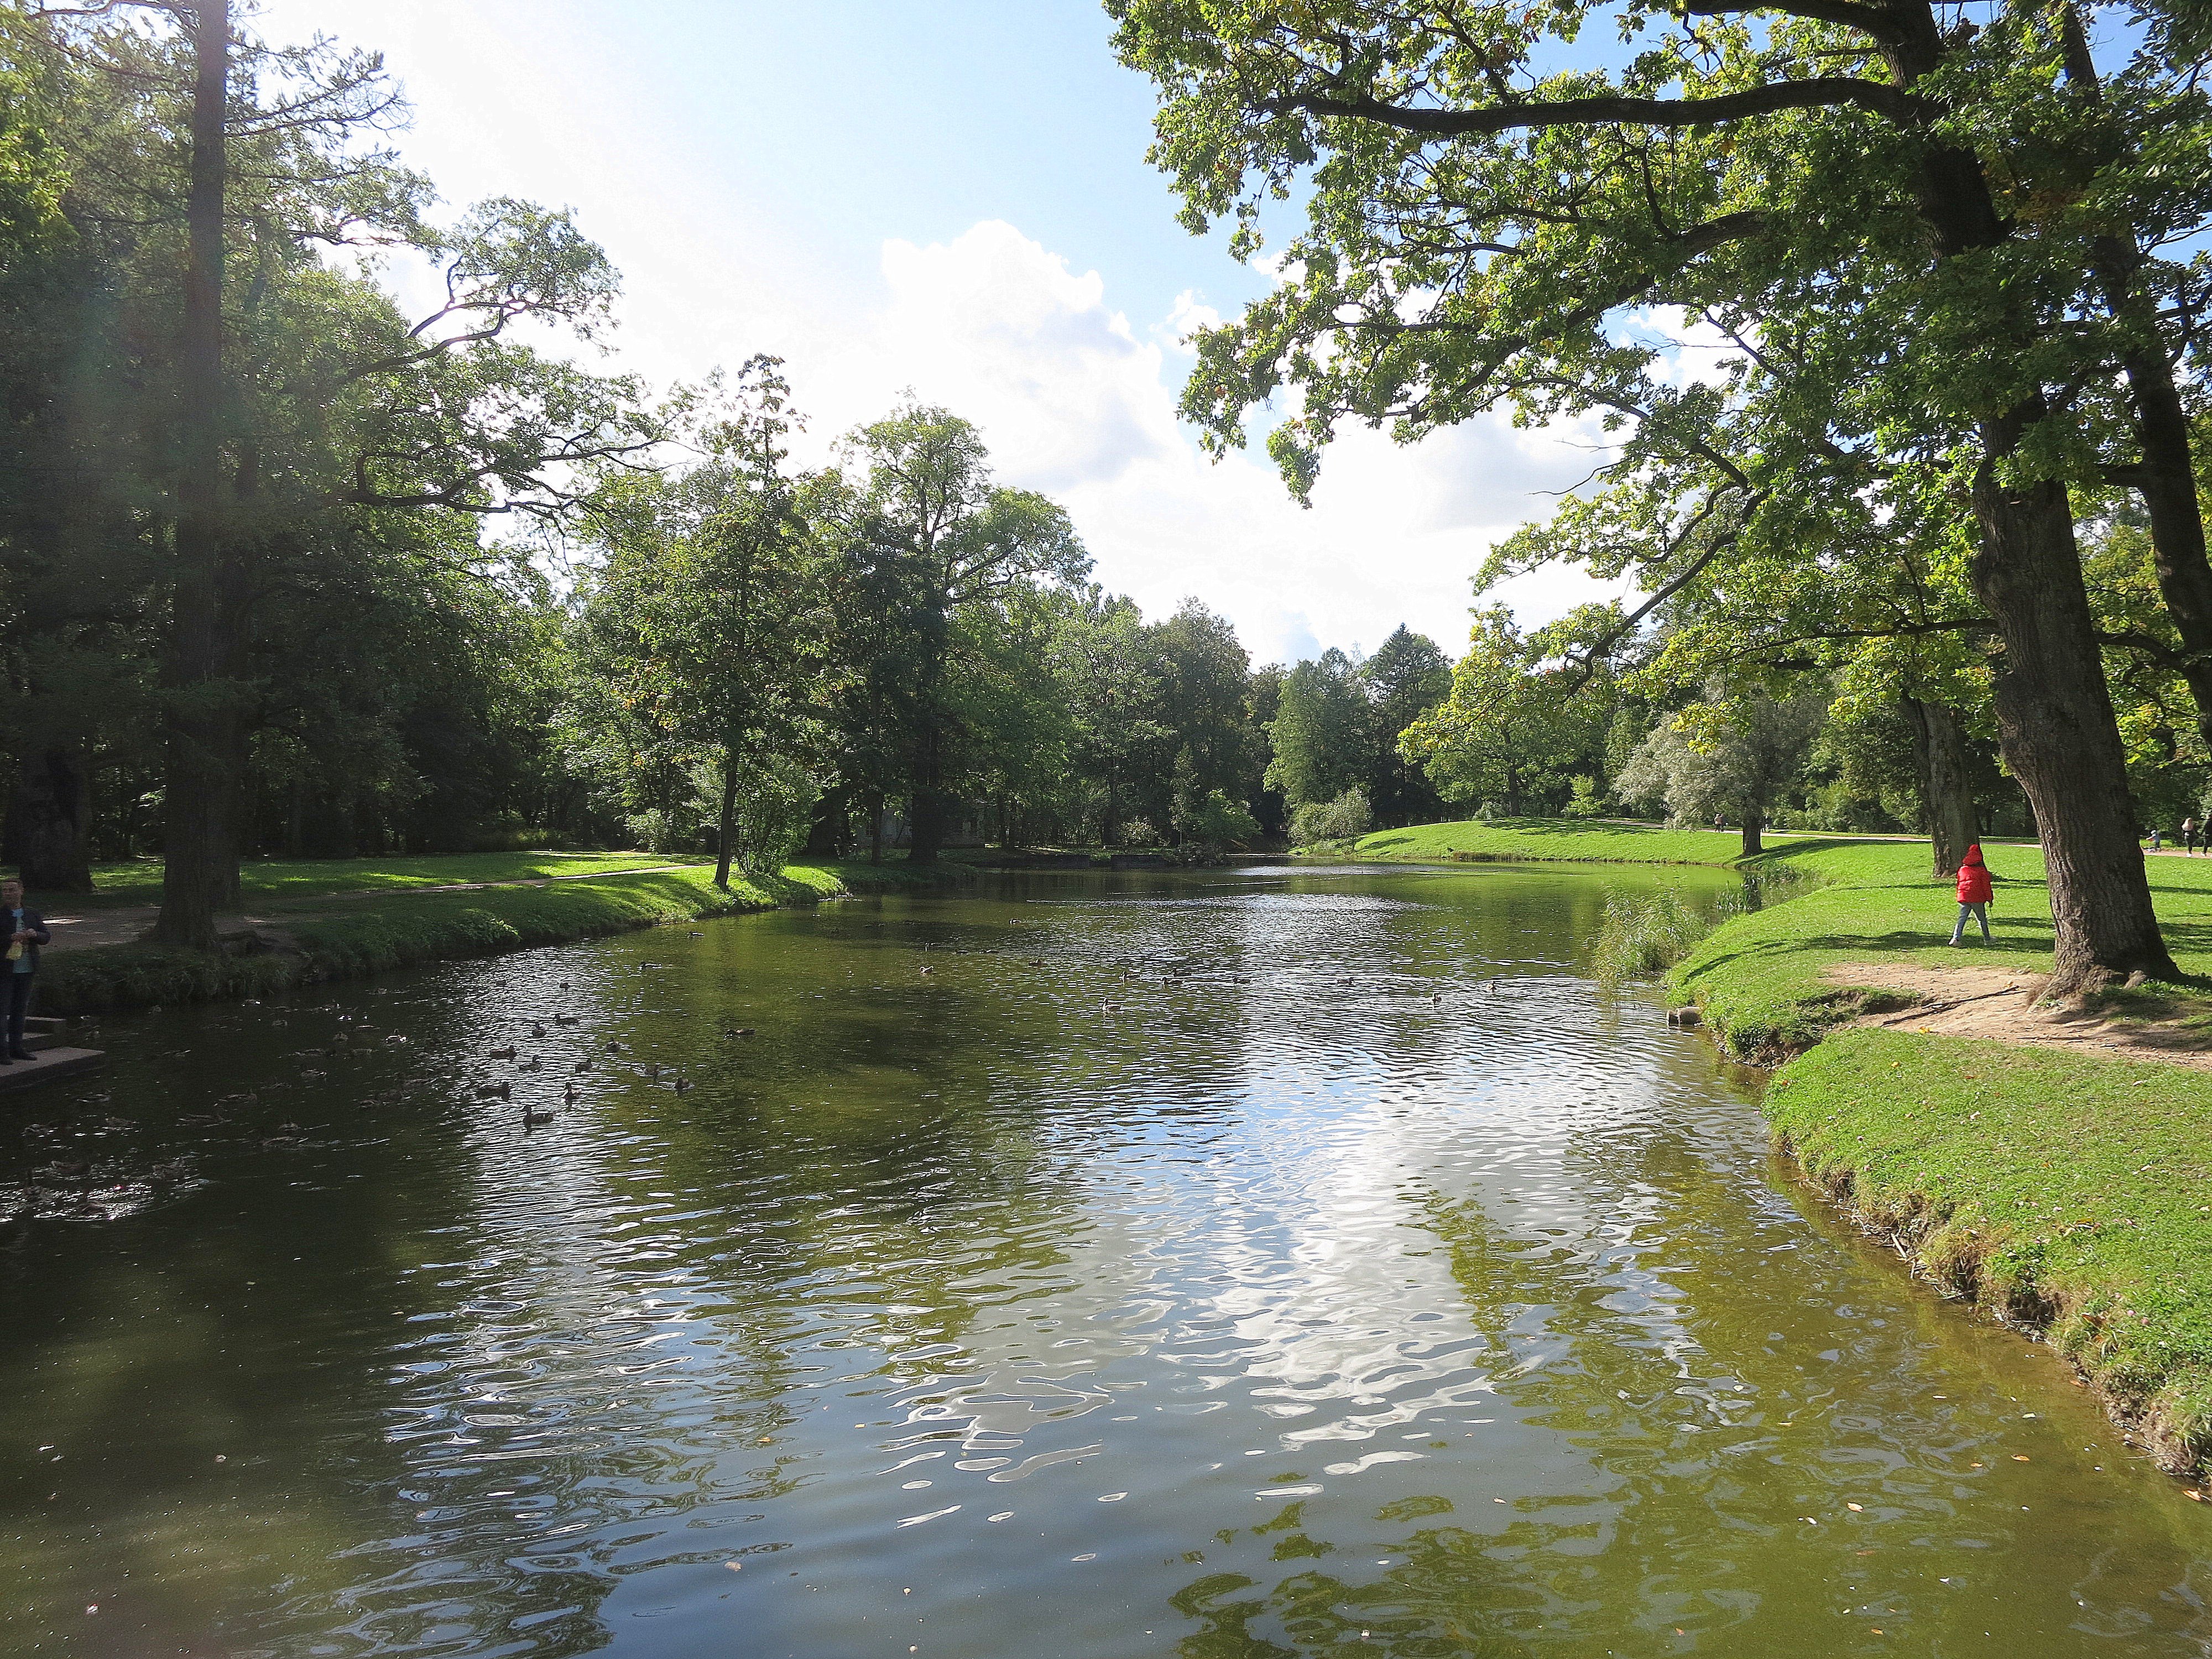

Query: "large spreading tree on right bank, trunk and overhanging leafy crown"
<box><xmin>1108</xmin><ymin>0</ymin><xmax>2201</xmax><ymax>993</ymax></box>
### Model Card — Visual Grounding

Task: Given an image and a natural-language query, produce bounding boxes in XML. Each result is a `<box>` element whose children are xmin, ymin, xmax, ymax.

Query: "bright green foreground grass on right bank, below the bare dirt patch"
<box><xmin>1765</xmin><ymin>1031</ymin><xmax>2212</xmax><ymax>1469</ymax></box>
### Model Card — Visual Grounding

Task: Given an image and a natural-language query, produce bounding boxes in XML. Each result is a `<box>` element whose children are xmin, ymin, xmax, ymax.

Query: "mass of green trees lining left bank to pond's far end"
<box><xmin>0</xmin><ymin>4</ymin><xmax>1449</xmax><ymax>925</ymax></box>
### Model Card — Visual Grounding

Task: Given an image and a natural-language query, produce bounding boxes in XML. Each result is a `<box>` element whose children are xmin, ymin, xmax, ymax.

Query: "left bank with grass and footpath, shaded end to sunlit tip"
<box><xmin>33</xmin><ymin>852</ymin><xmax>958</xmax><ymax>1015</ymax></box>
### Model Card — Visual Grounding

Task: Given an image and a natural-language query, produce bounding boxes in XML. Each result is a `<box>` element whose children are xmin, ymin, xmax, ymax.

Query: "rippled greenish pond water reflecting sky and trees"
<box><xmin>0</xmin><ymin>867</ymin><xmax>2212</xmax><ymax>1659</ymax></box>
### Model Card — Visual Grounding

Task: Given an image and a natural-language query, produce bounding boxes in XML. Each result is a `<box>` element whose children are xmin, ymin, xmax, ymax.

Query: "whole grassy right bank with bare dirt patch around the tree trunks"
<box><xmin>1349</xmin><ymin>818</ymin><xmax>2212</xmax><ymax>1475</ymax></box>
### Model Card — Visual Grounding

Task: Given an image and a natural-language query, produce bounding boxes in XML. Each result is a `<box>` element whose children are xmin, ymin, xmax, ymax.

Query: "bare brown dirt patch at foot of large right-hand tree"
<box><xmin>1820</xmin><ymin>962</ymin><xmax>2212</xmax><ymax>1071</ymax></box>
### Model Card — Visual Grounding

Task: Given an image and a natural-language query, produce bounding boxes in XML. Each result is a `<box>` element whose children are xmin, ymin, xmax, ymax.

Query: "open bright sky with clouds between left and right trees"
<box><xmin>254</xmin><ymin>0</ymin><xmax>1593</xmax><ymax>659</ymax></box>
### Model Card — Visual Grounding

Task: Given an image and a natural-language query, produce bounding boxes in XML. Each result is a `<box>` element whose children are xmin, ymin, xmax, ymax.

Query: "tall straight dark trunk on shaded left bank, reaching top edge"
<box><xmin>155</xmin><ymin>0</ymin><xmax>243</xmax><ymax>949</ymax></box>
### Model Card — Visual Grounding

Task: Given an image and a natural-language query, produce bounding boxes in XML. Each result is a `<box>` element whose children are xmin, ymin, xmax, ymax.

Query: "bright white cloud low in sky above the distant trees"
<box><xmin>792</xmin><ymin>221</ymin><xmax>1628</xmax><ymax>661</ymax></box>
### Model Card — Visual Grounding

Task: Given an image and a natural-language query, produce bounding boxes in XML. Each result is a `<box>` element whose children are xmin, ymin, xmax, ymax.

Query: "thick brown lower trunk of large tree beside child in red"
<box><xmin>1971</xmin><ymin>469</ymin><xmax>2177</xmax><ymax>998</ymax></box>
